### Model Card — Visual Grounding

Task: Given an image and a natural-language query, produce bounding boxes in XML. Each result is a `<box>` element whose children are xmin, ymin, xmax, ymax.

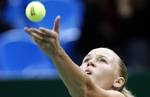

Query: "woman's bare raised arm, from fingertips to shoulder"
<box><xmin>25</xmin><ymin>16</ymin><xmax>125</xmax><ymax>97</ymax></box>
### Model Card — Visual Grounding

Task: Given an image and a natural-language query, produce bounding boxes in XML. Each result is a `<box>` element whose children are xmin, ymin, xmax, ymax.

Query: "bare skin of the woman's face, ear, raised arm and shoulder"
<box><xmin>25</xmin><ymin>16</ymin><xmax>125</xmax><ymax>97</ymax></box>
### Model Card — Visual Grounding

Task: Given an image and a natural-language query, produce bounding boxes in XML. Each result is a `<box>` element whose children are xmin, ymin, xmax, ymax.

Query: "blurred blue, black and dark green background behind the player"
<box><xmin>0</xmin><ymin>0</ymin><xmax>150</xmax><ymax>97</ymax></box>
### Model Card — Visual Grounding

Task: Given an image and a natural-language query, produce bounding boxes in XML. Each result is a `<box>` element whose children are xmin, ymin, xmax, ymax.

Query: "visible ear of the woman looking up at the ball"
<box><xmin>113</xmin><ymin>77</ymin><xmax>125</xmax><ymax>89</ymax></box>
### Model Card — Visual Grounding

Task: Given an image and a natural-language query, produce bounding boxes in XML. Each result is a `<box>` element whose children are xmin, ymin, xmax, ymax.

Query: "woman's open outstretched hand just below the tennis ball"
<box><xmin>24</xmin><ymin>16</ymin><xmax>60</xmax><ymax>55</ymax></box>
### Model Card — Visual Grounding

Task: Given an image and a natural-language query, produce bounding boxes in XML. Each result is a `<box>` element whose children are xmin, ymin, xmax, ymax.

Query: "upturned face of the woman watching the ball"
<box><xmin>80</xmin><ymin>48</ymin><xmax>119</xmax><ymax>90</ymax></box>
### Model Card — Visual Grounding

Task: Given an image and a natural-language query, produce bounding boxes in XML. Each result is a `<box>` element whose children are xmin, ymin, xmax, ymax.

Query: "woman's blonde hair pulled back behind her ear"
<box><xmin>118</xmin><ymin>59</ymin><xmax>135</xmax><ymax>97</ymax></box>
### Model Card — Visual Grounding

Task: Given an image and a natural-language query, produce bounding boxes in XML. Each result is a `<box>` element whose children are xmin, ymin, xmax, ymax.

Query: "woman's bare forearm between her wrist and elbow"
<box><xmin>49</xmin><ymin>47</ymin><xmax>87</xmax><ymax>94</ymax></box>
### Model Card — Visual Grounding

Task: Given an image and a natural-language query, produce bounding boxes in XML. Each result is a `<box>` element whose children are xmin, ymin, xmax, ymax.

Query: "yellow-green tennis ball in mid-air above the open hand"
<box><xmin>26</xmin><ymin>1</ymin><xmax>46</xmax><ymax>22</ymax></box>
